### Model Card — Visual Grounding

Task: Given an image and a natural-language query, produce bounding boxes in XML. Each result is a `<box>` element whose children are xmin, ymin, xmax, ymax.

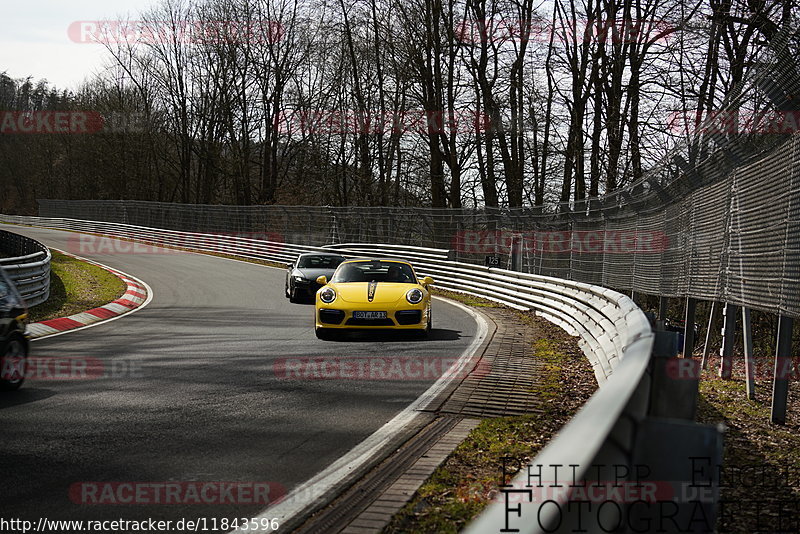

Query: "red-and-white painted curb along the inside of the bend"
<box><xmin>28</xmin><ymin>249</ymin><xmax>152</xmax><ymax>339</ymax></box>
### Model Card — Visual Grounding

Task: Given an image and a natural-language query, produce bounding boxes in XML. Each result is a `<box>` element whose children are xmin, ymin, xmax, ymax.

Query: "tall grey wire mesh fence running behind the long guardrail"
<box><xmin>34</xmin><ymin>130</ymin><xmax>800</xmax><ymax>317</ymax></box>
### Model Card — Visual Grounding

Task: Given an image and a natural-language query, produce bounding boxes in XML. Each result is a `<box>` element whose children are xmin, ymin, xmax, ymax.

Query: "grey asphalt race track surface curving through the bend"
<box><xmin>0</xmin><ymin>225</ymin><xmax>476</xmax><ymax>532</ymax></box>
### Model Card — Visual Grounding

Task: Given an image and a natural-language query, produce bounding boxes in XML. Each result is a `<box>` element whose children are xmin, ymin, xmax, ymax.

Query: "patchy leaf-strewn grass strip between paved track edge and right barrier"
<box><xmin>383</xmin><ymin>312</ymin><xmax>597</xmax><ymax>534</ymax></box>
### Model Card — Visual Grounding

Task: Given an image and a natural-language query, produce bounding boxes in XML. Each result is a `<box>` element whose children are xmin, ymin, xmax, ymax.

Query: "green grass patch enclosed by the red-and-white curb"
<box><xmin>28</xmin><ymin>250</ymin><xmax>126</xmax><ymax>322</ymax></box>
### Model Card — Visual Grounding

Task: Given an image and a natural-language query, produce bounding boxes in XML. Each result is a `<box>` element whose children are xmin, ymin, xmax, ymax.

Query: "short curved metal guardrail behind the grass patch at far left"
<box><xmin>0</xmin><ymin>230</ymin><xmax>51</xmax><ymax>306</ymax></box>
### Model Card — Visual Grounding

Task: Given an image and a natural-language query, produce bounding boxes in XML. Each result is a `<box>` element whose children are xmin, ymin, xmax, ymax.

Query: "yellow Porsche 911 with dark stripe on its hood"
<box><xmin>315</xmin><ymin>259</ymin><xmax>433</xmax><ymax>339</ymax></box>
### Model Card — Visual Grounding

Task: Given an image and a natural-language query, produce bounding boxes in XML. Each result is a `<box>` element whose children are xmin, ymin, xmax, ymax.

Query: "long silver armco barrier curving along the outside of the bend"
<box><xmin>2</xmin><ymin>216</ymin><xmax>721</xmax><ymax>534</ymax></box>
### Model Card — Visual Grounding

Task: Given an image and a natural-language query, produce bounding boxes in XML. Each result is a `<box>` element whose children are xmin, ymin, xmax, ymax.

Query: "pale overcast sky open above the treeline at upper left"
<box><xmin>0</xmin><ymin>0</ymin><xmax>157</xmax><ymax>89</ymax></box>
